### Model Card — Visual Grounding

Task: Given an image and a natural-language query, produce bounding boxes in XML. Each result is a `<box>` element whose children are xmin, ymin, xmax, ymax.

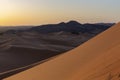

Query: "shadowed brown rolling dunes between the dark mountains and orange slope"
<box><xmin>0</xmin><ymin>31</ymin><xmax>95</xmax><ymax>79</ymax></box>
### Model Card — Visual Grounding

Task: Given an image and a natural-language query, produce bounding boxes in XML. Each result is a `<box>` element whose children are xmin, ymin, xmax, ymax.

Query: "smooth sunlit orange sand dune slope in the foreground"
<box><xmin>4</xmin><ymin>23</ymin><xmax>120</xmax><ymax>80</ymax></box>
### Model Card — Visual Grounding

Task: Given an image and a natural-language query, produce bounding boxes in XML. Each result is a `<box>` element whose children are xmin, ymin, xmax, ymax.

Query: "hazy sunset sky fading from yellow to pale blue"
<box><xmin>0</xmin><ymin>0</ymin><xmax>120</xmax><ymax>26</ymax></box>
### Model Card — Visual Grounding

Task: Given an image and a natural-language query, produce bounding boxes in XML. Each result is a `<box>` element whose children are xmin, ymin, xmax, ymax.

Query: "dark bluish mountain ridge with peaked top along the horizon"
<box><xmin>28</xmin><ymin>21</ymin><xmax>113</xmax><ymax>34</ymax></box>
